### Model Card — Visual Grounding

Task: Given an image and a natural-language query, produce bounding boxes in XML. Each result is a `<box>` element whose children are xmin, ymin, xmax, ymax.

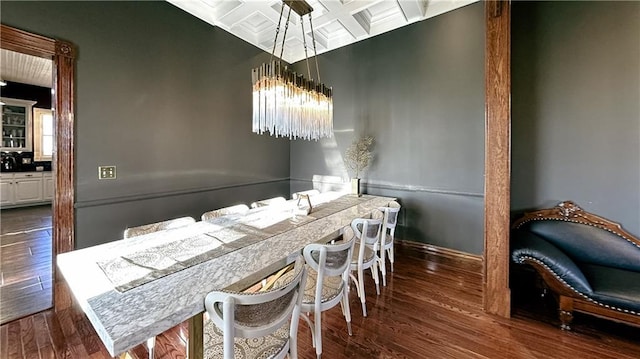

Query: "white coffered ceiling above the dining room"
<box><xmin>167</xmin><ymin>0</ymin><xmax>477</xmax><ymax>63</ymax></box>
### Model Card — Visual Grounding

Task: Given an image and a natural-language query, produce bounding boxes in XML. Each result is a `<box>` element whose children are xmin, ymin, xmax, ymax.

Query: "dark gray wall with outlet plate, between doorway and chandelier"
<box><xmin>1</xmin><ymin>1</ymin><xmax>289</xmax><ymax>248</ymax></box>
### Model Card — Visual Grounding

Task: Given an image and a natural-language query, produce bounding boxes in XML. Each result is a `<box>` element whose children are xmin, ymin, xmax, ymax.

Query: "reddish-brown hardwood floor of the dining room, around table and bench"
<box><xmin>0</xmin><ymin>245</ymin><xmax>640</xmax><ymax>359</ymax></box>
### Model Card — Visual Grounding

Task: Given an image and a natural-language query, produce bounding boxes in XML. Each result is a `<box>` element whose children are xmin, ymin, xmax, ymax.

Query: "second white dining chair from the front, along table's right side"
<box><xmin>301</xmin><ymin>236</ymin><xmax>355</xmax><ymax>358</ymax></box>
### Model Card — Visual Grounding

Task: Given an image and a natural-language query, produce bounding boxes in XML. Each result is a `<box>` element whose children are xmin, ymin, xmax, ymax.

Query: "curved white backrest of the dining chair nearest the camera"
<box><xmin>204</xmin><ymin>256</ymin><xmax>307</xmax><ymax>359</ymax></box>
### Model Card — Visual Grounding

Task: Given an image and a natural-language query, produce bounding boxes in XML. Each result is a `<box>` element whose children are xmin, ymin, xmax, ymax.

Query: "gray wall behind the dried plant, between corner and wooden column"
<box><xmin>290</xmin><ymin>3</ymin><xmax>484</xmax><ymax>254</ymax></box>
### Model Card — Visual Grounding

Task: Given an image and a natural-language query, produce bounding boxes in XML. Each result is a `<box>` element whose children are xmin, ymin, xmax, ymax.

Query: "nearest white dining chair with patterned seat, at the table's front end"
<box><xmin>204</xmin><ymin>257</ymin><xmax>307</xmax><ymax>359</ymax></box>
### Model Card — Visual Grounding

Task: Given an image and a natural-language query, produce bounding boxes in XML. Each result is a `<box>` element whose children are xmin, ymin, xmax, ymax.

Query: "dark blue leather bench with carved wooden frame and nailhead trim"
<box><xmin>511</xmin><ymin>201</ymin><xmax>640</xmax><ymax>329</ymax></box>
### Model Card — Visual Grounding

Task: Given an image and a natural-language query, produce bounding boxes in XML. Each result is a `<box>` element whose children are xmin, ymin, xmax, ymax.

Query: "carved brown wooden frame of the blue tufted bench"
<box><xmin>512</xmin><ymin>201</ymin><xmax>640</xmax><ymax>330</ymax></box>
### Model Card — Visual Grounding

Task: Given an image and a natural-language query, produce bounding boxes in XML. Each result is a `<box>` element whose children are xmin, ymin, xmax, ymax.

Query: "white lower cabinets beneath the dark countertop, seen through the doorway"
<box><xmin>0</xmin><ymin>172</ymin><xmax>53</xmax><ymax>208</ymax></box>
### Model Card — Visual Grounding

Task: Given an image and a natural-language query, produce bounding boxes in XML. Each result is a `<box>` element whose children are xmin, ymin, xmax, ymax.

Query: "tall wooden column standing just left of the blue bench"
<box><xmin>483</xmin><ymin>0</ymin><xmax>511</xmax><ymax>317</ymax></box>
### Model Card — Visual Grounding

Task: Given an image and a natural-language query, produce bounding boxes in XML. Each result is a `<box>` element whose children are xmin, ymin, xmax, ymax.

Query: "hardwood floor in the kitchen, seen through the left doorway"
<box><xmin>0</xmin><ymin>205</ymin><xmax>53</xmax><ymax>324</ymax></box>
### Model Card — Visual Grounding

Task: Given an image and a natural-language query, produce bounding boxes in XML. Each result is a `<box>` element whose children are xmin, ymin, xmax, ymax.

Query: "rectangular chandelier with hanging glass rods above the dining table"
<box><xmin>251</xmin><ymin>0</ymin><xmax>333</xmax><ymax>141</ymax></box>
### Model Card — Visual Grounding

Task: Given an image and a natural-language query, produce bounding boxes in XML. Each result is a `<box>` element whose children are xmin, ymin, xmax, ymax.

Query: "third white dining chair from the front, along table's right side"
<box><xmin>349</xmin><ymin>218</ymin><xmax>382</xmax><ymax>317</ymax></box>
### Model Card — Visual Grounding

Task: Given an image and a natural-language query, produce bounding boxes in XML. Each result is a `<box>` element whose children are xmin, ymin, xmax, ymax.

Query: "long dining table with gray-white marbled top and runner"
<box><xmin>56</xmin><ymin>194</ymin><xmax>395</xmax><ymax>359</ymax></box>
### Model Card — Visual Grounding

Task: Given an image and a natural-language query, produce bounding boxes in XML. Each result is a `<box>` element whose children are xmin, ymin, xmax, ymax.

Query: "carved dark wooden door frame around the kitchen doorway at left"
<box><xmin>0</xmin><ymin>24</ymin><xmax>76</xmax><ymax>310</ymax></box>
